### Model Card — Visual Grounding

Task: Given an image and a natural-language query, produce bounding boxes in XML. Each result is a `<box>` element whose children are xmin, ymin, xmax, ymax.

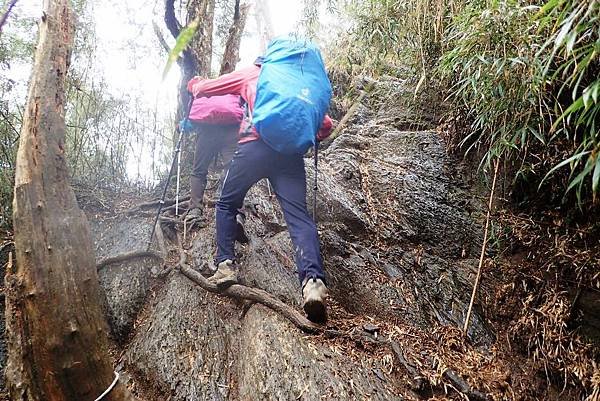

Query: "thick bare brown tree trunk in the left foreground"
<box><xmin>6</xmin><ymin>0</ymin><xmax>131</xmax><ymax>400</ymax></box>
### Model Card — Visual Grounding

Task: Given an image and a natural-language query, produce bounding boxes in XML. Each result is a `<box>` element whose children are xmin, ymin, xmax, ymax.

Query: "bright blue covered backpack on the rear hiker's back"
<box><xmin>252</xmin><ymin>37</ymin><xmax>331</xmax><ymax>154</ymax></box>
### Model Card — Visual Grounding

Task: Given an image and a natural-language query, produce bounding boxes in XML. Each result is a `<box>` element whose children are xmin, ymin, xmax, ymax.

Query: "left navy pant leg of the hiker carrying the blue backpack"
<box><xmin>216</xmin><ymin>141</ymin><xmax>269</xmax><ymax>263</ymax></box>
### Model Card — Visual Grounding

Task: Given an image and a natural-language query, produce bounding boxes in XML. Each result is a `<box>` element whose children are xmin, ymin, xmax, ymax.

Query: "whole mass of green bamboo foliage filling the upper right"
<box><xmin>340</xmin><ymin>0</ymin><xmax>600</xmax><ymax>203</ymax></box>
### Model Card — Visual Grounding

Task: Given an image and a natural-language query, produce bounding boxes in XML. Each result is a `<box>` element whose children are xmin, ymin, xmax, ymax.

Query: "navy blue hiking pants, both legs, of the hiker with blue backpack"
<box><xmin>216</xmin><ymin>139</ymin><xmax>324</xmax><ymax>282</ymax></box>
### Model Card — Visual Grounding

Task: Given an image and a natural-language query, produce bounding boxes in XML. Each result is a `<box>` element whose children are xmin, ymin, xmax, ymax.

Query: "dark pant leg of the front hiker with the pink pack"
<box><xmin>189</xmin><ymin>128</ymin><xmax>219</xmax><ymax>209</ymax></box>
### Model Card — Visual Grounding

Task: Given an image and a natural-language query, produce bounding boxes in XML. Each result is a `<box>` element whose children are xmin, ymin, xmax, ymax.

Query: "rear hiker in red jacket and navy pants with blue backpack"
<box><xmin>188</xmin><ymin>37</ymin><xmax>332</xmax><ymax>322</ymax></box>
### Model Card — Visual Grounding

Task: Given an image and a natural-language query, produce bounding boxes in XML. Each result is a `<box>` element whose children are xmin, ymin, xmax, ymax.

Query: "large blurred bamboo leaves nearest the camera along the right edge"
<box><xmin>538</xmin><ymin>0</ymin><xmax>600</xmax><ymax>202</ymax></box>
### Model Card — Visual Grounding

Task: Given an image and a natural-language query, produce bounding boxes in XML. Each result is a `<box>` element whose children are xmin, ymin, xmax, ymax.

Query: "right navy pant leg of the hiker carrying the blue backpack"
<box><xmin>269</xmin><ymin>154</ymin><xmax>325</xmax><ymax>282</ymax></box>
